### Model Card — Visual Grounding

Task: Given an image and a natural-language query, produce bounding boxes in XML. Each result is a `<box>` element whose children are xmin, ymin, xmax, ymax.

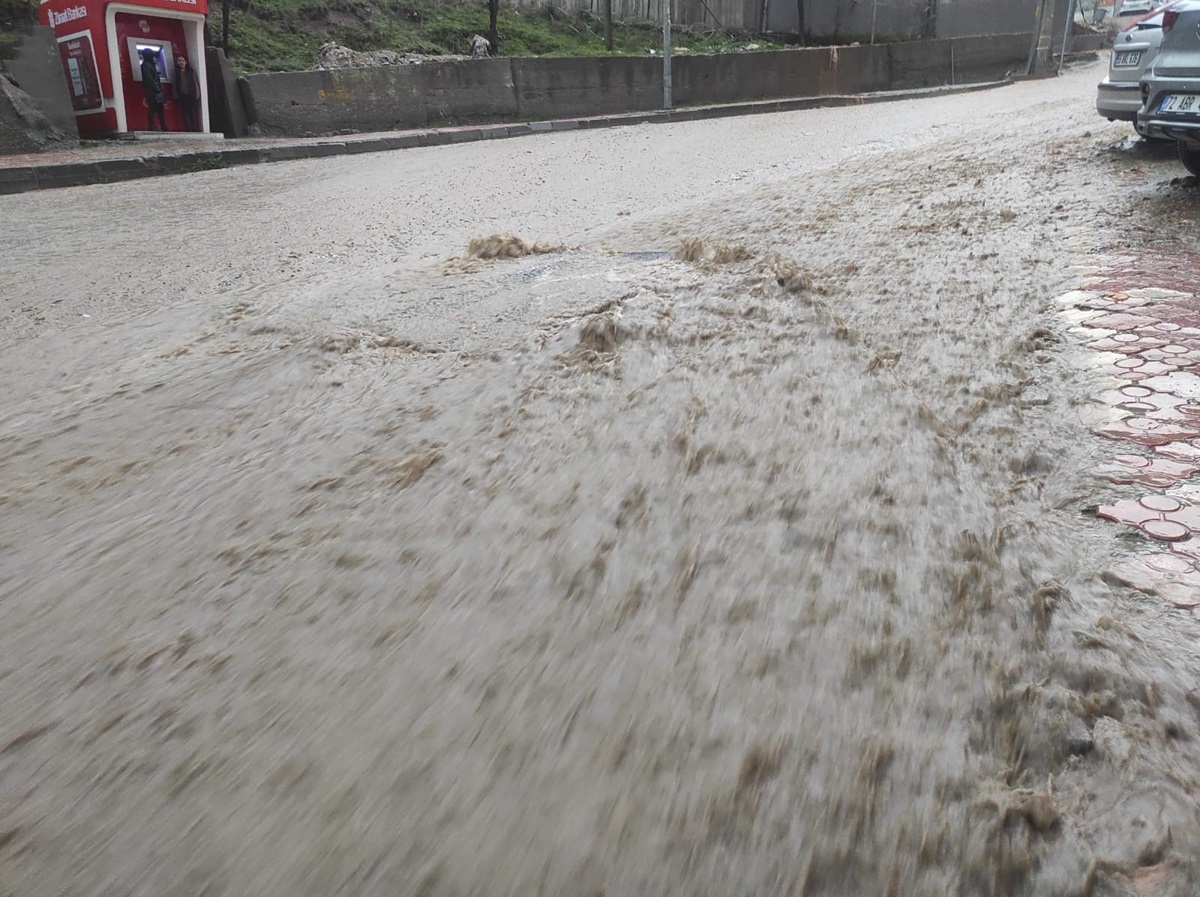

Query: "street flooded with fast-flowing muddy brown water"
<box><xmin>0</xmin><ymin>64</ymin><xmax>1200</xmax><ymax>897</ymax></box>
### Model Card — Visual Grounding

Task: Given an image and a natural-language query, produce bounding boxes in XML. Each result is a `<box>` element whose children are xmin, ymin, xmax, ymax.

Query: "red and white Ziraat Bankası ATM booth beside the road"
<box><xmin>40</xmin><ymin>0</ymin><xmax>209</xmax><ymax>137</ymax></box>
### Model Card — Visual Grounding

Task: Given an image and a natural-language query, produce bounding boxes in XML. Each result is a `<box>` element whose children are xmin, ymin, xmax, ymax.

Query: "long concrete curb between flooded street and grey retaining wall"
<box><xmin>0</xmin><ymin>79</ymin><xmax>1013</xmax><ymax>195</ymax></box>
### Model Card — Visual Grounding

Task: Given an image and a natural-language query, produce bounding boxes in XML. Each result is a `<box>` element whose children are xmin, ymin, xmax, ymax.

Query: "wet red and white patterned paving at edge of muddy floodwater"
<box><xmin>1058</xmin><ymin>252</ymin><xmax>1200</xmax><ymax>606</ymax></box>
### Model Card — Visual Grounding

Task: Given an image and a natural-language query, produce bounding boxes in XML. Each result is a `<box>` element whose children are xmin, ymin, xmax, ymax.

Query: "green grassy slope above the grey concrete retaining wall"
<box><xmin>209</xmin><ymin>0</ymin><xmax>773</xmax><ymax>72</ymax></box>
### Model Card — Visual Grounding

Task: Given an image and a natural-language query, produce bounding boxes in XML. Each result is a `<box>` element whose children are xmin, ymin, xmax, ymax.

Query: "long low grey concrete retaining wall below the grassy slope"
<box><xmin>246</xmin><ymin>34</ymin><xmax>1031</xmax><ymax>137</ymax></box>
